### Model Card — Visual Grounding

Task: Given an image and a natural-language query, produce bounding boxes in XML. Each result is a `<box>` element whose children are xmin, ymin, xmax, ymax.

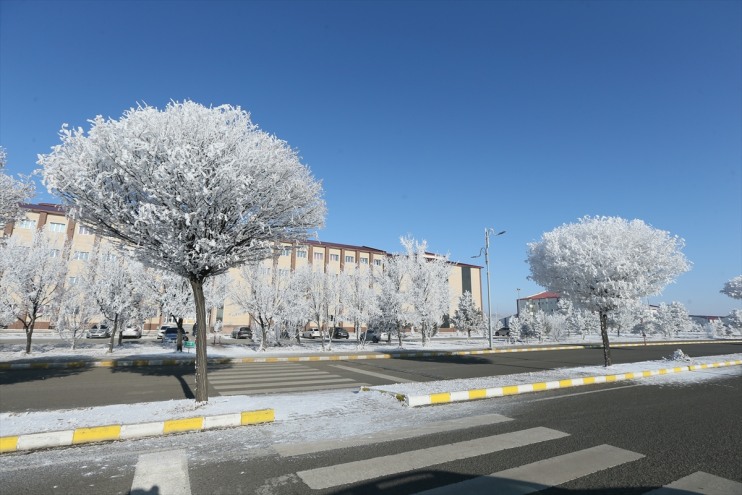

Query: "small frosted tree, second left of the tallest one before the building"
<box><xmin>340</xmin><ymin>266</ymin><xmax>379</xmax><ymax>342</ymax></box>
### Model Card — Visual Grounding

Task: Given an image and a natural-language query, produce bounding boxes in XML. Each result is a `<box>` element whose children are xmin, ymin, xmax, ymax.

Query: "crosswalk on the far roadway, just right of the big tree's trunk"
<box><xmin>209</xmin><ymin>363</ymin><xmax>367</xmax><ymax>395</ymax></box>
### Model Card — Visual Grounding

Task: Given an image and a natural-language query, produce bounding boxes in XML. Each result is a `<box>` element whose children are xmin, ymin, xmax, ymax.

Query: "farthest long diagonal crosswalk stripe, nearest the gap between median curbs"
<box><xmin>273</xmin><ymin>414</ymin><xmax>512</xmax><ymax>457</ymax></box>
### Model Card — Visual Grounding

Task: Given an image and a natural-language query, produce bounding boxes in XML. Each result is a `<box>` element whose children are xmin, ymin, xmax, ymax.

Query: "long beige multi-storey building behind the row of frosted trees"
<box><xmin>3</xmin><ymin>203</ymin><xmax>482</xmax><ymax>331</ymax></box>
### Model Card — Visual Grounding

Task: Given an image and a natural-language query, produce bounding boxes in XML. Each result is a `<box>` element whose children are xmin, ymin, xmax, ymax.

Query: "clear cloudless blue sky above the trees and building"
<box><xmin>0</xmin><ymin>0</ymin><xmax>742</xmax><ymax>315</ymax></box>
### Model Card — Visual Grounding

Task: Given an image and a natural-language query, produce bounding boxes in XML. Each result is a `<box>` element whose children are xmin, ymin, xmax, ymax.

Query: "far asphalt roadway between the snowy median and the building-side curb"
<box><xmin>0</xmin><ymin>343</ymin><xmax>742</xmax><ymax>412</ymax></box>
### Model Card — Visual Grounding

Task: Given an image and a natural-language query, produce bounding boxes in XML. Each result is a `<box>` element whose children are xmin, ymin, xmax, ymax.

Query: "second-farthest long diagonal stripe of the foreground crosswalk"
<box><xmin>296</xmin><ymin>427</ymin><xmax>569</xmax><ymax>490</ymax></box>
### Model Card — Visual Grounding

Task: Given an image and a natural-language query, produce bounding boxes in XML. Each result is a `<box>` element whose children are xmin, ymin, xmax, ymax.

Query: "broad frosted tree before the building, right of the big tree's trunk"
<box><xmin>229</xmin><ymin>264</ymin><xmax>289</xmax><ymax>351</ymax></box>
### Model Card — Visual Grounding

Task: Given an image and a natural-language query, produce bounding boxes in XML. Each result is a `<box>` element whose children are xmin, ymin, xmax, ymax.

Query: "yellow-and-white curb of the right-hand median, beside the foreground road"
<box><xmin>361</xmin><ymin>359</ymin><xmax>742</xmax><ymax>407</ymax></box>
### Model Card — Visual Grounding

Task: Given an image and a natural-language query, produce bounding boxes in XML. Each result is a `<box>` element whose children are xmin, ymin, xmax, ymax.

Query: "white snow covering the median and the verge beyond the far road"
<box><xmin>0</xmin><ymin>332</ymin><xmax>742</xmax><ymax>436</ymax></box>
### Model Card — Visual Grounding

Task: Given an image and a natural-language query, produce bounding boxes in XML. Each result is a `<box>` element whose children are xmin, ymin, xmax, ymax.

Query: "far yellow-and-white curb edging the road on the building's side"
<box><xmin>7</xmin><ymin>340</ymin><xmax>742</xmax><ymax>370</ymax></box>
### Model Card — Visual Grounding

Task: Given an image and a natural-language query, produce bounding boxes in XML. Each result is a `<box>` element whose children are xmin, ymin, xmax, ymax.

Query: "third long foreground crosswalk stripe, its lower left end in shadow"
<box><xmin>417</xmin><ymin>445</ymin><xmax>644</xmax><ymax>495</ymax></box>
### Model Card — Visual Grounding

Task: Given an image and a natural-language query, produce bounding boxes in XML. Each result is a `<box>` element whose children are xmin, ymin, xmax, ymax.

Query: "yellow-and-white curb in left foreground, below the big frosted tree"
<box><xmin>0</xmin><ymin>409</ymin><xmax>275</xmax><ymax>453</ymax></box>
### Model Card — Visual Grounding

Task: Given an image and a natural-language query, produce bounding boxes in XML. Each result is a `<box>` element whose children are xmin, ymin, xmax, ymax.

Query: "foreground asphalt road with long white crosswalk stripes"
<box><xmin>0</xmin><ymin>368</ymin><xmax>742</xmax><ymax>495</ymax></box>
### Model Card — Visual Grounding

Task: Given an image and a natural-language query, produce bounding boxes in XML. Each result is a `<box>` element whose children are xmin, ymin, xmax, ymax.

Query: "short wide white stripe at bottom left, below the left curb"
<box><xmin>130</xmin><ymin>450</ymin><xmax>191</xmax><ymax>495</ymax></box>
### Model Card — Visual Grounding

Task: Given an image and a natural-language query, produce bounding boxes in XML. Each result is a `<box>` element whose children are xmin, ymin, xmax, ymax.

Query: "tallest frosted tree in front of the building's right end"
<box><xmin>400</xmin><ymin>237</ymin><xmax>451</xmax><ymax>346</ymax></box>
